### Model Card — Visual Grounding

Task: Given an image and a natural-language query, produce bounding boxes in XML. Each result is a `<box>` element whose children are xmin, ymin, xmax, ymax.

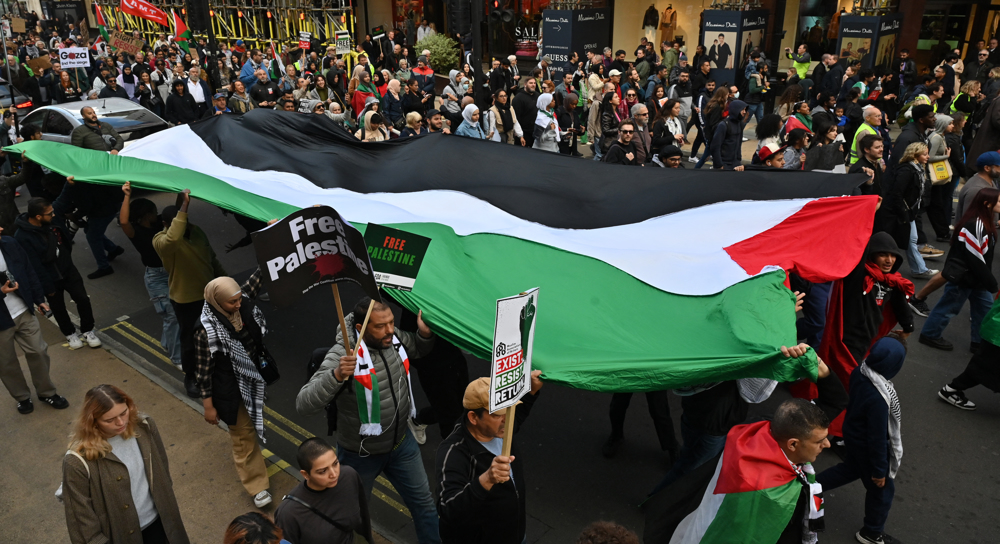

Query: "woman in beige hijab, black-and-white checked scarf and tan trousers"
<box><xmin>194</xmin><ymin>268</ymin><xmax>278</xmax><ymax>508</ymax></box>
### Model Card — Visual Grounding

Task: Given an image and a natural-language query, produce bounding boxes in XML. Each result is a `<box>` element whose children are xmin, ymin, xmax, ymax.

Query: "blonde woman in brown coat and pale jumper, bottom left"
<box><xmin>62</xmin><ymin>385</ymin><xmax>189</xmax><ymax>544</ymax></box>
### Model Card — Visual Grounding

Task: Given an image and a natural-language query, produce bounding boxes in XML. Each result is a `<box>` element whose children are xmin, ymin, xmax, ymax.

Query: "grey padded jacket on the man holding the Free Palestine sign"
<box><xmin>295</xmin><ymin>314</ymin><xmax>435</xmax><ymax>455</ymax></box>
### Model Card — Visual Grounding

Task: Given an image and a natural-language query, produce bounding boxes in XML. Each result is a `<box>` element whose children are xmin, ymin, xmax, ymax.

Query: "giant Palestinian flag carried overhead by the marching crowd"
<box><xmin>5</xmin><ymin>109</ymin><xmax>875</xmax><ymax>391</ymax></box>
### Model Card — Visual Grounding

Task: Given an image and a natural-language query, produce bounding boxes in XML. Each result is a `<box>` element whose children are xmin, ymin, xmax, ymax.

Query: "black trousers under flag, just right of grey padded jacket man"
<box><xmin>413</xmin><ymin>336</ymin><xmax>469</xmax><ymax>438</ymax></box>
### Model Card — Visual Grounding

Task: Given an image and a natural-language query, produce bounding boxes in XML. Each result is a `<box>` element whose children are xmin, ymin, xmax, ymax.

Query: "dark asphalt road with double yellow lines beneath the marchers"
<box><xmin>25</xmin><ymin>188</ymin><xmax>1000</xmax><ymax>544</ymax></box>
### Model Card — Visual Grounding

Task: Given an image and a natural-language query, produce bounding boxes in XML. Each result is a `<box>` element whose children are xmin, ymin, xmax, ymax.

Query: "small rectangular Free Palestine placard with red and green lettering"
<box><xmin>365</xmin><ymin>223</ymin><xmax>431</xmax><ymax>291</ymax></box>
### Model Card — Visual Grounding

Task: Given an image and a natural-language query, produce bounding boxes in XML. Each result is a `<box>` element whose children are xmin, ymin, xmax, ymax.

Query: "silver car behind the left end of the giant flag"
<box><xmin>21</xmin><ymin>98</ymin><xmax>168</xmax><ymax>146</ymax></box>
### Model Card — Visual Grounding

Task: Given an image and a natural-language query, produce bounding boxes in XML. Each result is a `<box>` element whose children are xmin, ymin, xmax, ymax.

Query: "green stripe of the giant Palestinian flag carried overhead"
<box><xmin>7</xmin><ymin>141</ymin><xmax>816</xmax><ymax>392</ymax></box>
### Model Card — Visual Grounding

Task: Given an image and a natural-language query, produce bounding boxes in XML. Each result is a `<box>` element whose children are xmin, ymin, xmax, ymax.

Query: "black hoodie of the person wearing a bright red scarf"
<box><xmin>843</xmin><ymin>232</ymin><xmax>913</xmax><ymax>363</ymax></box>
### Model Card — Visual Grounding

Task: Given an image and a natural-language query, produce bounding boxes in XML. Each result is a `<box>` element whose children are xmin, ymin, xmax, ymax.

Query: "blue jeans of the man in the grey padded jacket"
<box><xmin>337</xmin><ymin>426</ymin><xmax>441</xmax><ymax>544</ymax></box>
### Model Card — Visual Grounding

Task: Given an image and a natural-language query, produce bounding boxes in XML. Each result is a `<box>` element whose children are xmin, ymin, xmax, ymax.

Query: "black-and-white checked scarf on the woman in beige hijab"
<box><xmin>201</xmin><ymin>300</ymin><xmax>267</xmax><ymax>444</ymax></box>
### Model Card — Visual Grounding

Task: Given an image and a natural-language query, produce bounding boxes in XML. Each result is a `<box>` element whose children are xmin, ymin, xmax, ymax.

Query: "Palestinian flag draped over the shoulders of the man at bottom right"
<box><xmin>643</xmin><ymin>421</ymin><xmax>823</xmax><ymax>544</ymax></box>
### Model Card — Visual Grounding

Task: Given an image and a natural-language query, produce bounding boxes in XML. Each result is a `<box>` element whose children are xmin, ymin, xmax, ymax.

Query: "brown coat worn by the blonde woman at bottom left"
<box><xmin>63</xmin><ymin>417</ymin><xmax>189</xmax><ymax>544</ymax></box>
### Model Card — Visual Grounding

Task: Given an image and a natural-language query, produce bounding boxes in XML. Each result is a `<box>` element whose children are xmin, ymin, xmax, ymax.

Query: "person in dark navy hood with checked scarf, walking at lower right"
<box><xmin>816</xmin><ymin>337</ymin><xmax>906</xmax><ymax>544</ymax></box>
